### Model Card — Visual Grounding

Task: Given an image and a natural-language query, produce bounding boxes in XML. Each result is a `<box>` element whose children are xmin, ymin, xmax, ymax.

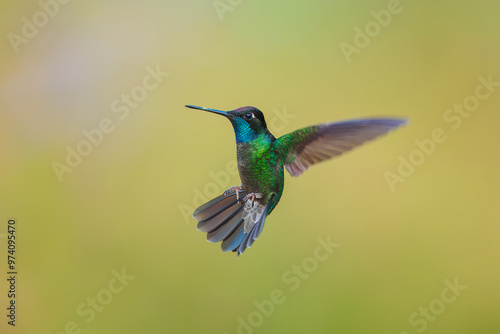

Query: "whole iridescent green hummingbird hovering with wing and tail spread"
<box><xmin>186</xmin><ymin>105</ymin><xmax>407</xmax><ymax>256</ymax></box>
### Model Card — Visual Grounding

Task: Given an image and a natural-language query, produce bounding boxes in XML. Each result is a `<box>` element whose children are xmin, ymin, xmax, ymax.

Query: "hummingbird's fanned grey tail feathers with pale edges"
<box><xmin>193</xmin><ymin>191</ymin><xmax>270</xmax><ymax>255</ymax></box>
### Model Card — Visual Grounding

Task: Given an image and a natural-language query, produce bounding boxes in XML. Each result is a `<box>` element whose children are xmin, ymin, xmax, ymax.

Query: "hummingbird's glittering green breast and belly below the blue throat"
<box><xmin>237</xmin><ymin>140</ymin><xmax>284</xmax><ymax>204</ymax></box>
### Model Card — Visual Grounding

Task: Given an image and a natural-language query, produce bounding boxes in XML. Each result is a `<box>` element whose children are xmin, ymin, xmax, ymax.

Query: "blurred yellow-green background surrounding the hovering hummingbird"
<box><xmin>0</xmin><ymin>0</ymin><xmax>500</xmax><ymax>334</ymax></box>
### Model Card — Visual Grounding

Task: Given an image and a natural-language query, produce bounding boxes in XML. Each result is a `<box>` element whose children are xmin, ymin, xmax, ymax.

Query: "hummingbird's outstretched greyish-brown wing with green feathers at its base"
<box><xmin>275</xmin><ymin>118</ymin><xmax>407</xmax><ymax>177</ymax></box>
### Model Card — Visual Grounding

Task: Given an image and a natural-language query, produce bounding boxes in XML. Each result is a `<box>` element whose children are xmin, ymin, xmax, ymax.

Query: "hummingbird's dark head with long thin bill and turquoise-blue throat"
<box><xmin>186</xmin><ymin>105</ymin><xmax>274</xmax><ymax>143</ymax></box>
